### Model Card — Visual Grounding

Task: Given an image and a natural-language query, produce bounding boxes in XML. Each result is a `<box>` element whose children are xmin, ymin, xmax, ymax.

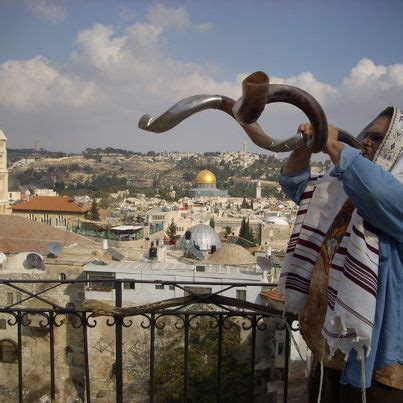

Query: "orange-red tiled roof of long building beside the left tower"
<box><xmin>10</xmin><ymin>196</ymin><xmax>91</xmax><ymax>213</ymax></box>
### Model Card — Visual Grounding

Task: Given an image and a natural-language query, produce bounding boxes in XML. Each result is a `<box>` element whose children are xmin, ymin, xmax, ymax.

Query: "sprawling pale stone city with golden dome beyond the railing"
<box><xmin>0</xmin><ymin>132</ymin><xmax>326</xmax><ymax>401</ymax></box>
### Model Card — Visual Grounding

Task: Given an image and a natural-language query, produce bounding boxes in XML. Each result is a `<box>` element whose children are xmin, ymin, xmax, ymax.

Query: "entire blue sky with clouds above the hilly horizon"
<box><xmin>0</xmin><ymin>0</ymin><xmax>403</xmax><ymax>153</ymax></box>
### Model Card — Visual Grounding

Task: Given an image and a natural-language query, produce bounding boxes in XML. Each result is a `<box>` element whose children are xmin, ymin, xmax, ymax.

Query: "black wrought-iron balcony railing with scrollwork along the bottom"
<box><xmin>0</xmin><ymin>279</ymin><xmax>306</xmax><ymax>402</ymax></box>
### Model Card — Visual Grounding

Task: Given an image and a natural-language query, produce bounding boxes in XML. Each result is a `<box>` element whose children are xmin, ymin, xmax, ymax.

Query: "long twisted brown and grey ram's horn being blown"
<box><xmin>139</xmin><ymin>71</ymin><xmax>358</xmax><ymax>152</ymax></box>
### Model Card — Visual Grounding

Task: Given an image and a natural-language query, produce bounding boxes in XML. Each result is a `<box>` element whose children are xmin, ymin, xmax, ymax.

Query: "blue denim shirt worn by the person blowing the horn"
<box><xmin>279</xmin><ymin>145</ymin><xmax>403</xmax><ymax>387</ymax></box>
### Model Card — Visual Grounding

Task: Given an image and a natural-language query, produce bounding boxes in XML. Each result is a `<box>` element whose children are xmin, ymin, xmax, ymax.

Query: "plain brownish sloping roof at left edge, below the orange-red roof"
<box><xmin>0</xmin><ymin>214</ymin><xmax>99</xmax><ymax>255</ymax></box>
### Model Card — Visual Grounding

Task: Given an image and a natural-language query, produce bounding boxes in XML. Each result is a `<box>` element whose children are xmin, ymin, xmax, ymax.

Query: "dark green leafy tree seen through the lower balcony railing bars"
<box><xmin>155</xmin><ymin>316</ymin><xmax>250</xmax><ymax>403</ymax></box>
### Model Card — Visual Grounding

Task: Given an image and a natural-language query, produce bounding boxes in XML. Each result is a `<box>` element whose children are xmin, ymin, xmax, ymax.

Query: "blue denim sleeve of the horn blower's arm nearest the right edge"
<box><xmin>331</xmin><ymin>145</ymin><xmax>403</xmax><ymax>241</ymax></box>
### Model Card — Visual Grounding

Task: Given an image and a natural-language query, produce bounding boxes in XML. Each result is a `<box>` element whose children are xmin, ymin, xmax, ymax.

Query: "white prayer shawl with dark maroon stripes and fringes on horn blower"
<box><xmin>279</xmin><ymin>108</ymin><xmax>403</xmax><ymax>360</ymax></box>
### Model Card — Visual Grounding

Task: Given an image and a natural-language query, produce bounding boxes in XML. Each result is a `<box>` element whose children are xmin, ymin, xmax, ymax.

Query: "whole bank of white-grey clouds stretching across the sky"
<box><xmin>0</xmin><ymin>4</ymin><xmax>403</xmax><ymax>150</ymax></box>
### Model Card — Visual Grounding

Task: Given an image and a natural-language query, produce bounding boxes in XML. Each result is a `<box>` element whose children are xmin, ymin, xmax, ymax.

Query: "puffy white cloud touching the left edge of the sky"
<box><xmin>0</xmin><ymin>56</ymin><xmax>97</xmax><ymax>109</ymax></box>
